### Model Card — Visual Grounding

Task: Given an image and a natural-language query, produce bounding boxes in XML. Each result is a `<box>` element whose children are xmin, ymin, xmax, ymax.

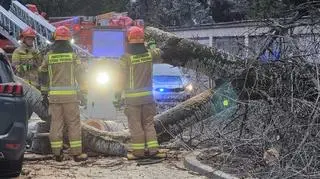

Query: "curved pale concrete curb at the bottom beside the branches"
<box><xmin>183</xmin><ymin>151</ymin><xmax>239</xmax><ymax>179</ymax></box>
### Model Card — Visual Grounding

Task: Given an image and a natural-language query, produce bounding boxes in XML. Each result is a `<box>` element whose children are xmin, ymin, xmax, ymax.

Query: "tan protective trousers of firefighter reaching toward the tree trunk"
<box><xmin>125</xmin><ymin>103</ymin><xmax>159</xmax><ymax>157</ymax></box>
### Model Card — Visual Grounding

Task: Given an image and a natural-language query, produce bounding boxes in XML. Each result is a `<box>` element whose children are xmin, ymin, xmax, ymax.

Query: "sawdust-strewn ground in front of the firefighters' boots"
<box><xmin>19</xmin><ymin>152</ymin><xmax>206</xmax><ymax>179</ymax></box>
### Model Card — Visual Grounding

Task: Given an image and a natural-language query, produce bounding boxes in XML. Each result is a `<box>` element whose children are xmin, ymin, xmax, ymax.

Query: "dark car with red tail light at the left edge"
<box><xmin>0</xmin><ymin>49</ymin><xmax>27</xmax><ymax>177</ymax></box>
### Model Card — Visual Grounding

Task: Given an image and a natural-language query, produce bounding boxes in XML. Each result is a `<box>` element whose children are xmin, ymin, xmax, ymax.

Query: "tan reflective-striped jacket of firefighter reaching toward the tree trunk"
<box><xmin>120</xmin><ymin>48</ymin><xmax>160</xmax><ymax>105</ymax></box>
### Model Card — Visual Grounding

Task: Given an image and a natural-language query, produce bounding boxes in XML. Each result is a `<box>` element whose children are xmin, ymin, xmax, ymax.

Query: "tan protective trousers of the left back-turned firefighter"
<box><xmin>49</xmin><ymin>103</ymin><xmax>82</xmax><ymax>155</ymax></box>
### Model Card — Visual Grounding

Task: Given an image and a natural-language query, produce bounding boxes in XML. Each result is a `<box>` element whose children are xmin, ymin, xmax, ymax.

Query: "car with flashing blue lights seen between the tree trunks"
<box><xmin>153</xmin><ymin>64</ymin><xmax>193</xmax><ymax>103</ymax></box>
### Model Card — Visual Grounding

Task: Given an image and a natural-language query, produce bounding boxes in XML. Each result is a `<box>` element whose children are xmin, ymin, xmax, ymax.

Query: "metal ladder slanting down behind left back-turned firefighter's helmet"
<box><xmin>10</xmin><ymin>0</ymin><xmax>92</xmax><ymax>57</ymax></box>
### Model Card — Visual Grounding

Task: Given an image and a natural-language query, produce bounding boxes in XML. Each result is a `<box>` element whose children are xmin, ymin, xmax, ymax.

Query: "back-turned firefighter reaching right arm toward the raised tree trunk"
<box><xmin>115</xmin><ymin>26</ymin><xmax>165</xmax><ymax>159</ymax></box>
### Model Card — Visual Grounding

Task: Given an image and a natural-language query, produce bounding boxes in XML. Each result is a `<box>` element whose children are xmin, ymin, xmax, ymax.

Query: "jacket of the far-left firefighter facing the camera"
<box><xmin>12</xmin><ymin>44</ymin><xmax>42</xmax><ymax>86</ymax></box>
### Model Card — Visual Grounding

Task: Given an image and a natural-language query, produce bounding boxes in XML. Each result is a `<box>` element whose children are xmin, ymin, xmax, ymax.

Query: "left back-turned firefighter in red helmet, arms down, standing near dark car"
<box><xmin>39</xmin><ymin>26</ymin><xmax>88</xmax><ymax>162</ymax></box>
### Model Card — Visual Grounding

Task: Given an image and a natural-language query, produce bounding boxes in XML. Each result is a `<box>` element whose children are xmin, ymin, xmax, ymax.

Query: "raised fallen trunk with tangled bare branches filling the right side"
<box><xmin>147</xmin><ymin>6</ymin><xmax>320</xmax><ymax>178</ymax></box>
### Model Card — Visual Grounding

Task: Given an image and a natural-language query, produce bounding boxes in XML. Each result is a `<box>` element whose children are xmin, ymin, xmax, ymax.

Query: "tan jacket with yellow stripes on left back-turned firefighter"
<box><xmin>39</xmin><ymin>52</ymin><xmax>83</xmax><ymax>103</ymax></box>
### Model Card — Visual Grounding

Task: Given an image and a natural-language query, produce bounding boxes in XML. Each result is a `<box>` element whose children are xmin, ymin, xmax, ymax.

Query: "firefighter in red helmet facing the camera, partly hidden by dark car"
<box><xmin>12</xmin><ymin>27</ymin><xmax>42</xmax><ymax>88</ymax></box>
